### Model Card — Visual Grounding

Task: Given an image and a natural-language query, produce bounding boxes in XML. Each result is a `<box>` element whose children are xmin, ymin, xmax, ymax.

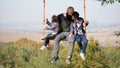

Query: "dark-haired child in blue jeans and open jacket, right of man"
<box><xmin>69</xmin><ymin>12</ymin><xmax>88</xmax><ymax>60</ymax></box>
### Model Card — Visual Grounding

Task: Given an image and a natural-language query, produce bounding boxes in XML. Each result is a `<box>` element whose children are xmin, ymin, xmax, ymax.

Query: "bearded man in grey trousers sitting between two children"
<box><xmin>51</xmin><ymin>7</ymin><xmax>75</xmax><ymax>64</ymax></box>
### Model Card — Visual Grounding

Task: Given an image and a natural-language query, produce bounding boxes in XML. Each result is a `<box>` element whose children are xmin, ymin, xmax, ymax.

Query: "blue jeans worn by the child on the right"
<box><xmin>75</xmin><ymin>34</ymin><xmax>88</xmax><ymax>54</ymax></box>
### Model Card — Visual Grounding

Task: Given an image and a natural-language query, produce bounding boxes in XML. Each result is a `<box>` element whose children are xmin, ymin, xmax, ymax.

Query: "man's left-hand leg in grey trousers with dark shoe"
<box><xmin>51</xmin><ymin>33</ymin><xmax>65</xmax><ymax>63</ymax></box>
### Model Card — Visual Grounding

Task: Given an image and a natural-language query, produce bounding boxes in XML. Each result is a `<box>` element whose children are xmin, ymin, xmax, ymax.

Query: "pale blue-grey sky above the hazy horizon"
<box><xmin>0</xmin><ymin>0</ymin><xmax>120</xmax><ymax>24</ymax></box>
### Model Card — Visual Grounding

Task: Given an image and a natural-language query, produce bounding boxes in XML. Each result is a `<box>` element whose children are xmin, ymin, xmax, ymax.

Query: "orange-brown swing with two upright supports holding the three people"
<box><xmin>41</xmin><ymin>0</ymin><xmax>89</xmax><ymax>40</ymax></box>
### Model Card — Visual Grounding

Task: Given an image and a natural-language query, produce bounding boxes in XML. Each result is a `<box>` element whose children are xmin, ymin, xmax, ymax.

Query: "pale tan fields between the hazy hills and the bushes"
<box><xmin>0</xmin><ymin>30</ymin><xmax>120</xmax><ymax>46</ymax></box>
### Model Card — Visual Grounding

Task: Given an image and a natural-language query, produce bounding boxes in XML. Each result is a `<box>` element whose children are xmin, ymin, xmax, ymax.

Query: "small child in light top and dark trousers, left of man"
<box><xmin>40</xmin><ymin>15</ymin><xmax>59</xmax><ymax>50</ymax></box>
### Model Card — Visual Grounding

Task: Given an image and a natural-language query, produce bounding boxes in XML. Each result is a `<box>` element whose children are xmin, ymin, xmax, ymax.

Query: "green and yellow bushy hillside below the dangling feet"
<box><xmin>0</xmin><ymin>37</ymin><xmax>120</xmax><ymax>68</ymax></box>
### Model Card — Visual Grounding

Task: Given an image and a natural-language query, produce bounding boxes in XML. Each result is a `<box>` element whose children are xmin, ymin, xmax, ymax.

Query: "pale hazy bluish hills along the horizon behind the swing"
<box><xmin>0</xmin><ymin>21</ymin><xmax>120</xmax><ymax>32</ymax></box>
